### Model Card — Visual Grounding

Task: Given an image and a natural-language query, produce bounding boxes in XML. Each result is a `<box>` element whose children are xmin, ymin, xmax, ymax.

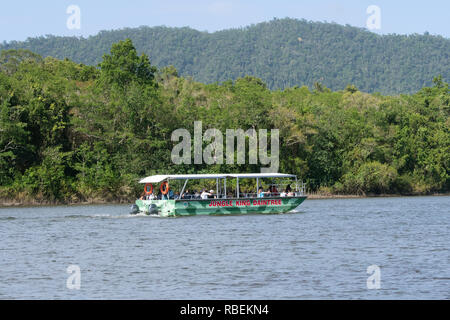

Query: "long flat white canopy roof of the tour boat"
<box><xmin>139</xmin><ymin>173</ymin><xmax>296</xmax><ymax>183</ymax></box>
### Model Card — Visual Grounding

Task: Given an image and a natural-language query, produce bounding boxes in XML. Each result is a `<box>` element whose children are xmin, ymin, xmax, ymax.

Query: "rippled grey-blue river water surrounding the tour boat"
<box><xmin>0</xmin><ymin>197</ymin><xmax>450</xmax><ymax>299</ymax></box>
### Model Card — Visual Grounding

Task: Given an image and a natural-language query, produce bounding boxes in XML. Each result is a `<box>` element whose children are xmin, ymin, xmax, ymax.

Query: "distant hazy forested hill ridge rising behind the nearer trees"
<box><xmin>0</xmin><ymin>19</ymin><xmax>450</xmax><ymax>94</ymax></box>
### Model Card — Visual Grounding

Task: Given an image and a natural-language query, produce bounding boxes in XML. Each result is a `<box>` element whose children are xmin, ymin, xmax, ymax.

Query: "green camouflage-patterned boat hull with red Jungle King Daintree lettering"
<box><xmin>136</xmin><ymin>196</ymin><xmax>306</xmax><ymax>217</ymax></box>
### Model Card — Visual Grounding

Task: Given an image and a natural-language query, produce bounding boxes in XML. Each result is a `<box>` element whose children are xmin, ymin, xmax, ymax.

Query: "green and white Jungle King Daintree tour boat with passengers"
<box><xmin>132</xmin><ymin>173</ymin><xmax>306</xmax><ymax>217</ymax></box>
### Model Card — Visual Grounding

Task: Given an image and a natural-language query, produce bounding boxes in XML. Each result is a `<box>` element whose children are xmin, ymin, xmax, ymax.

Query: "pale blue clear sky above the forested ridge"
<box><xmin>0</xmin><ymin>0</ymin><xmax>450</xmax><ymax>42</ymax></box>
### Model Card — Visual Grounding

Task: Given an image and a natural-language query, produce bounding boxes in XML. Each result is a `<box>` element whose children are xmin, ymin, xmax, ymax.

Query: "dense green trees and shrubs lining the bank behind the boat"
<box><xmin>0</xmin><ymin>40</ymin><xmax>450</xmax><ymax>202</ymax></box>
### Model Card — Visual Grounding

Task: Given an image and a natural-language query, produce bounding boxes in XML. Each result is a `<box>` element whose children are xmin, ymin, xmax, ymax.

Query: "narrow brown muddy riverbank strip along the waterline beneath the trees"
<box><xmin>0</xmin><ymin>193</ymin><xmax>450</xmax><ymax>208</ymax></box>
